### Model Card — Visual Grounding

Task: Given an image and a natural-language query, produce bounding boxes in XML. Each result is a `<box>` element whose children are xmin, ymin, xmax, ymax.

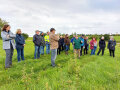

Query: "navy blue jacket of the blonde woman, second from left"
<box><xmin>15</xmin><ymin>34</ymin><xmax>25</xmax><ymax>49</ymax></box>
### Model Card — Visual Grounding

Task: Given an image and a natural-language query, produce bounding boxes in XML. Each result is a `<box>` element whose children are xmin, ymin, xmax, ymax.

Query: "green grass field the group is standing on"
<box><xmin>0</xmin><ymin>37</ymin><xmax>120</xmax><ymax>90</ymax></box>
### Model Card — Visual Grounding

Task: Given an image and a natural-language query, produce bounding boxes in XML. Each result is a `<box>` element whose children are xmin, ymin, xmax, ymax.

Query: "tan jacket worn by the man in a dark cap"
<box><xmin>49</xmin><ymin>32</ymin><xmax>59</xmax><ymax>49</ymax></box>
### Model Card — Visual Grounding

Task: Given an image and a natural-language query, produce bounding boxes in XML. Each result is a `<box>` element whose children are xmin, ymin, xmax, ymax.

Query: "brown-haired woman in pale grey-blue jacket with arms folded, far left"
<box><xmin>1</xmin><ymin>25</ymin><xmax>16</xmax><ymax>68</ymax></box>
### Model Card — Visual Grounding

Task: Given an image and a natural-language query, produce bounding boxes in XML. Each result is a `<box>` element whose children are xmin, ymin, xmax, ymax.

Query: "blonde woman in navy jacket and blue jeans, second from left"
<box><xmin>15</xmin><ymin>29</ymin><xmax>25</xmax><ymax>62</ymax></box>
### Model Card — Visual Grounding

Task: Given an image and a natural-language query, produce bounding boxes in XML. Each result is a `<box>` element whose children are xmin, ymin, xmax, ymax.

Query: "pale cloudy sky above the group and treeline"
<box><xmin>0</xmin><ymin>0</ymin><xmax>120</xmax><ymax>36</ymax></box>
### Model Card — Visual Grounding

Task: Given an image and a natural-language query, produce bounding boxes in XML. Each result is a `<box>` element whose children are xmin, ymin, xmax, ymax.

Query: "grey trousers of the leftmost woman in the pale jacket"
<box><xmin>5</xmin><ymin>45</ymin><xmax>14</xmax><ymax>68</ymax></box>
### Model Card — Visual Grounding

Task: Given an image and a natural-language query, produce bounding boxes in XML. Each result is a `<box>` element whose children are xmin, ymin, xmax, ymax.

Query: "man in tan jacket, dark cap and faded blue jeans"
<box><xmin>49</xmin><ymin>28</ymin><xmax>59</xmax><ymax>67</ymax></box>
